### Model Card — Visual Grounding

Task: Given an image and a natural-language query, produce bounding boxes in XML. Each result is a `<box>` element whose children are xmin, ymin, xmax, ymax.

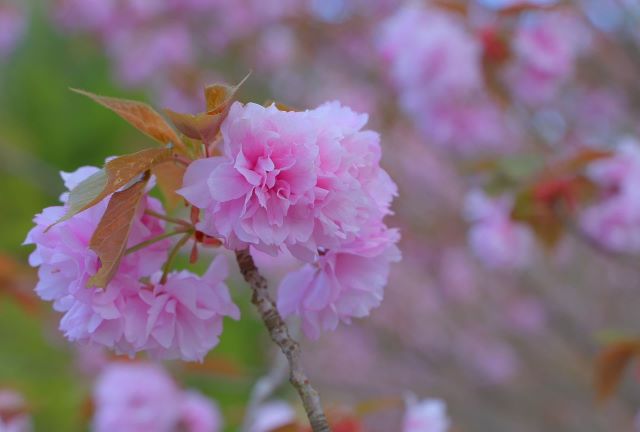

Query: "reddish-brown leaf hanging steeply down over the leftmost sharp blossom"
<box><xmin>88</xmin><ymin>172</ymin><xmax>149</xmax><ymax>288</ymax></box>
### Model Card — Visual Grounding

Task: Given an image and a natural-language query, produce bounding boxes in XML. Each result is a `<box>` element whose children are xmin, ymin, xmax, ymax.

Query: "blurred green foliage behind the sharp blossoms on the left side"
<box><xmin>0</xmin><ymin>5</ymin><xmax>267</xmax><ymax>431</ymax></box>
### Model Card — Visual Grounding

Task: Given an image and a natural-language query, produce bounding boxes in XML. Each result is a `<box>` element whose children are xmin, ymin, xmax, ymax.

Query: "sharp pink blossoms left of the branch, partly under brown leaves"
<box><xmin>25</xmin><ymin>167</ymin><xmax>239</xmax><ymax>360</ymax></box>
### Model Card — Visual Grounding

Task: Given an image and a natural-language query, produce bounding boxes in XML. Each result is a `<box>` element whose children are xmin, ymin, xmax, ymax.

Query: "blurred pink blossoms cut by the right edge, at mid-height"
<box><xmin>581</xmin><ymin>139</ymin><xmax>640</xmax><ymax>253</ymax></box>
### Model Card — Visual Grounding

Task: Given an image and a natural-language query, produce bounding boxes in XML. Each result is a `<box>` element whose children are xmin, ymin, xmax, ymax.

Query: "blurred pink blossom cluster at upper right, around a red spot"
<box><xmin>377</xmin><ymin>2</ymin><xmax>586</xmax><ymax>155</ymax></box>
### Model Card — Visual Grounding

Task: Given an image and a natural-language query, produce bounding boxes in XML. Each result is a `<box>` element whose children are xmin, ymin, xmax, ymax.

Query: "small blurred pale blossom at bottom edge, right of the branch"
<box><xmin>402</xmin><ymin>397</ymin><xmax>450</xmax><ymax>432</ymax></box>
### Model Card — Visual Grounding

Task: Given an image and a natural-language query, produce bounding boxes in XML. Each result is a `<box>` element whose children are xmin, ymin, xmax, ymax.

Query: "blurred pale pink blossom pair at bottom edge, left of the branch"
<box><xmin>93</xmin><ymin>363</ymin><xmax>222</xmax><ymax>432</ymax></box>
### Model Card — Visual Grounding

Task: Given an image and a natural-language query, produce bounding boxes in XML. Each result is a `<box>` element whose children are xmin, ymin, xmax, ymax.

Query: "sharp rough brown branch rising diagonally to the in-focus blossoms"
<box><xmin>236</xmin><ymin>249</ymin><xmax>331</xmax><ymax>432</ymax></box>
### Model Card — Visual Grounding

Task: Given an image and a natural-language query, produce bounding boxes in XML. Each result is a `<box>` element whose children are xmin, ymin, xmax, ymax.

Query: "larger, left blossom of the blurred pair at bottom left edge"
<box><xmin>93</xmin><ymin>363</ymin><xmax>182</xmax><ymax>432</ymax></box>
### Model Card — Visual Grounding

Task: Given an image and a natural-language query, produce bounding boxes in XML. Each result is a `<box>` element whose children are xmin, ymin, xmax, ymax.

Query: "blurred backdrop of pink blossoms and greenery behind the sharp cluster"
<box><xmin>0</xmin><ymin>0</ymin><xmax>640</xmax><ymax>432</ymax></box>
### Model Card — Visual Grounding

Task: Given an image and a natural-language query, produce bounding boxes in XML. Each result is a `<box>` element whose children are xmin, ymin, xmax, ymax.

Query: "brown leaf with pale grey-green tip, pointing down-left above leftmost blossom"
<box><xmin>52</xmin><ymin>148</ymin><xmax>173</xmax><ymax>229</ymax></box>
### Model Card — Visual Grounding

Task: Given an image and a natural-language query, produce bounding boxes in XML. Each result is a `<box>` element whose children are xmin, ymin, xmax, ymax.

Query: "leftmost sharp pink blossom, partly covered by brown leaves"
<box><xmin>25</xmin><ymin>167</ymin><xmax>169</xmax><ymax>353</ymax></box>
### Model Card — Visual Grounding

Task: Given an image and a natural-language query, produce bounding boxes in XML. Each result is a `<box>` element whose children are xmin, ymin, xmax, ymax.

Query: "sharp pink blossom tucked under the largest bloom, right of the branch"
<box><xmin>278</xmin><ymin>226</ymin><xmax>400</xmax><ymax>339</ymax></box>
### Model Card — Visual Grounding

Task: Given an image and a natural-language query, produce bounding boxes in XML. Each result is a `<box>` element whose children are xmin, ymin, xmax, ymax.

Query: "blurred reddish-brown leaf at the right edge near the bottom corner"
<box><xmin>595</xmin><ymin>339</ymin><xmax>640</xmax><ymax>402</ymax></box>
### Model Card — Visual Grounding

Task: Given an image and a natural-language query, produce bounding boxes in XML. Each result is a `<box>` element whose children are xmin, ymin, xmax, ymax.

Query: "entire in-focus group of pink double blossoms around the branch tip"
<box><xmin>25</xmin><ymin>102</ymin><xmax>400</xmax><ymax>361</ymax></box>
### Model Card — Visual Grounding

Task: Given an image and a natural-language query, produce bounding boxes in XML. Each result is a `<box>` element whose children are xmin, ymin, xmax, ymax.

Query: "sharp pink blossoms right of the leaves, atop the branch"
<box><xmin>179</xmin><ymin>102</ymin><xmax>400</xmax><ymax>339</ymax></box>
